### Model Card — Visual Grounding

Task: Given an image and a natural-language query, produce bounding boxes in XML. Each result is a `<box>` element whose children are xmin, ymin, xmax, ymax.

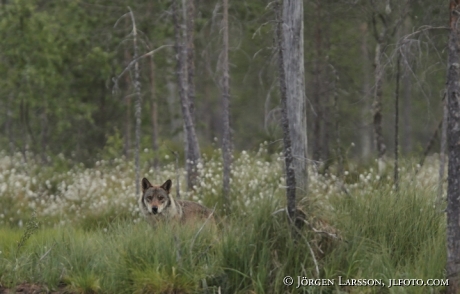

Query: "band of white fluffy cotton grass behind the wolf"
<box><xmin>0</xmin><ymin>148</ymin><xmax>446</xmax><ymax>226</ymax></box>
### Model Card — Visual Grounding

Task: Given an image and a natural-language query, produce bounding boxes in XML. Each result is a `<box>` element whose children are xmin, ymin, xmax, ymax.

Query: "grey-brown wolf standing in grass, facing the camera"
<box><xmin>139</xmin><ymin>178</ymin><xmax>214</xmax><ymax>225</ymax></box>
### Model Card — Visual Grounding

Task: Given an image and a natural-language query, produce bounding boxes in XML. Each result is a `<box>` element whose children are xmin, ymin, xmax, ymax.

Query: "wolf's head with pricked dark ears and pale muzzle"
<box><xmin>142</xmin><ymin>178</ymin><xmax>172</xmax><ymax>214</ymax></box>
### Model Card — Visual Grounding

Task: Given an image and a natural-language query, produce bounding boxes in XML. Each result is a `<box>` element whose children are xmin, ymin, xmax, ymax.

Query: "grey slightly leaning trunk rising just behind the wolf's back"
<box><xmin>173</xmin><ymin>0</ymin><xmax>201</xmax><ymax>189</ymax></box>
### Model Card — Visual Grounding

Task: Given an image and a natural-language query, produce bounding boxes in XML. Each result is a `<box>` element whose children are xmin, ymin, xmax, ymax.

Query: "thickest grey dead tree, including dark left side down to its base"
<box><xmin>275</xmin><ymin>0</ymin><xmax>307</xmax><ymax>224</ymax></box>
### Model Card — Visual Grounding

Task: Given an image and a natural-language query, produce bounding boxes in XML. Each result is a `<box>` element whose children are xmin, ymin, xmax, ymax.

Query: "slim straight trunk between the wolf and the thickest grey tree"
<box><xmin>222</xmin><ymin>0</ymin><xmax>232</xmax><ymax>213</ymax></box>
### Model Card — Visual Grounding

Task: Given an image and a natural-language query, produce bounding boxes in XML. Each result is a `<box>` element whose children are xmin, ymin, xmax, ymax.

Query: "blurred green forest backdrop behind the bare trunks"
<box><xmin>0</xmin><ymin>0</ymin><xmax>448</xmax><ymax>164</ymax></box>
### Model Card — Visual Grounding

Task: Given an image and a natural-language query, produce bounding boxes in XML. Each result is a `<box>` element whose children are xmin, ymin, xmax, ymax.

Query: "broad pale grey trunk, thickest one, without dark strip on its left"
<box><xmin>281</xmin><ymin>0</ymin><xmax>308</xmax><ymax>198</ymax></box>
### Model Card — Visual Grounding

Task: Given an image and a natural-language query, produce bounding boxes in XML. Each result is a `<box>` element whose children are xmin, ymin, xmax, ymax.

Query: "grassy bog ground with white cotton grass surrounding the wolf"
<box><xmin>0</xmin><ymin>144</ymin><xmax>446</xmax><ymax>293</ymax></box>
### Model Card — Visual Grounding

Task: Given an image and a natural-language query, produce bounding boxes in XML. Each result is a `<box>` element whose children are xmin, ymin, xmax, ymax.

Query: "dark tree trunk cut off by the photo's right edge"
<box><xmin>446</xmin><ymin>0</ymin><xmax>460</xmax><ymax>294</ymax></box>
